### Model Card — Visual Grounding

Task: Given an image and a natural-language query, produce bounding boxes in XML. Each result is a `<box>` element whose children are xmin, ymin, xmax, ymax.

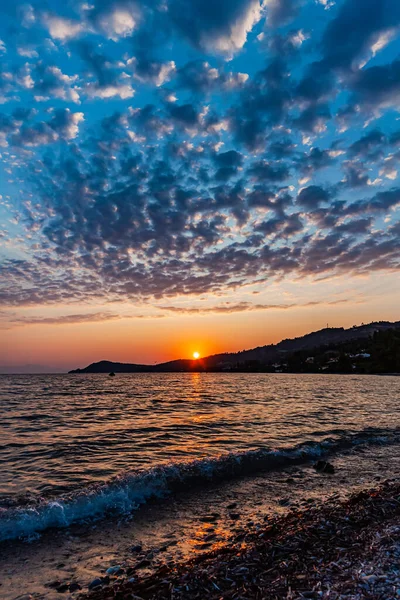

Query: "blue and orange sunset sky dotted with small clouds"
<box><xmin>0</xmin><ymin>0</ymin><xmax>400</xmax><ymax>370</ymax></box>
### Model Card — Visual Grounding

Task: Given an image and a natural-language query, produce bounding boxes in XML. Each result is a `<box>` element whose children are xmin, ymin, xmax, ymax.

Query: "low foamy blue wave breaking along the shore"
<box><xmin>0</xmin><ymin>428</ymin><xmax>400</xmax><ymax>542</ymax></box>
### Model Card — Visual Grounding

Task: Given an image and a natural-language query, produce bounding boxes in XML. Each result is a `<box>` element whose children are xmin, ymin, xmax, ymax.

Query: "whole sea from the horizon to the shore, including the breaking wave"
<box><xmin>0</xmin><ymin>373</ymin><xmax>400</xmax><ymax>541</ymax></box>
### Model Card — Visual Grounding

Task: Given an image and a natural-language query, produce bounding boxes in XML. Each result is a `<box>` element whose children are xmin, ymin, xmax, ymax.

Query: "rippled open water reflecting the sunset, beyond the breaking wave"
<box><xmin>0</xmin><ymin>373</ymin><xmax>400</xmax><ymax>499</ymax></box>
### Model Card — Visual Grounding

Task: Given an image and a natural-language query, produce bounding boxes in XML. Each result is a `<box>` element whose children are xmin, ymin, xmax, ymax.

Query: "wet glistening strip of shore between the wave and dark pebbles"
<box><xmin>0</xmin><ymin>445</ymin><xmax>400</xmax><ymax>600</ymax></box>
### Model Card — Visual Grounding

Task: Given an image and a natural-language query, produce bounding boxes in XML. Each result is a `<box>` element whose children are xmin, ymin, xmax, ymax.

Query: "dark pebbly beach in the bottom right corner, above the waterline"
<box><xmin>78</xmin><ymin>480</ymin><xmax>400</xmax><ymax>600</ymax></box>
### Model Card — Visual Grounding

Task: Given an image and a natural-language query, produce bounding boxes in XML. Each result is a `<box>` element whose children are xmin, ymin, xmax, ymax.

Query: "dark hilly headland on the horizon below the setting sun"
<box><xmin>69</xmin><ymin>321</ymin><xmax>400</xmax><ymax>375</ymax></box>
